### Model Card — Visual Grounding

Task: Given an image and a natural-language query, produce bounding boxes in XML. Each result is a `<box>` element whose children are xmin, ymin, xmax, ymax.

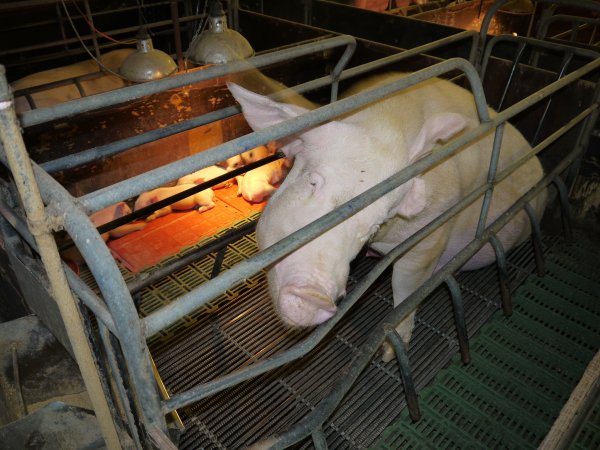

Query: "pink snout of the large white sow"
<box><xmin>278</xmin><ymin>286</ymin><xmax>337</xmax><ymax>327</ymax></box>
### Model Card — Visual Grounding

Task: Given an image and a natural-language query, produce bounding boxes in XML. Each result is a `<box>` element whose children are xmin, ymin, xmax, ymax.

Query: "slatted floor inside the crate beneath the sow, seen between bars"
<box><xmin>106</xmin><ymin>220</ymin><xmax>568</xmax><ymax>449</ymax></box>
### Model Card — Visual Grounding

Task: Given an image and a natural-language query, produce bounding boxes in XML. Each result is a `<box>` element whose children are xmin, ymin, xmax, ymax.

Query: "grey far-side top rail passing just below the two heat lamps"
<box><xmin>21</xmin><ymin>36</ymin><xmax>355</xmax><ymax>128</ymax></box>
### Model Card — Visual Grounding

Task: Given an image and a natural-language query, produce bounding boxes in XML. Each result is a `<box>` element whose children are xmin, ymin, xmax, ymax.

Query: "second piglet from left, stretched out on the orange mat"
<box><xmin>134</xmin><ymin>184</ymin><xmax>215</xmax><ymax>222</ymax></box>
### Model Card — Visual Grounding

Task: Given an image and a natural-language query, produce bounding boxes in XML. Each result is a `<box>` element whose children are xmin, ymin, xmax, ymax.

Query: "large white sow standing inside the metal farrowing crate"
<box><xmin>229</xmin><ymin>74</ymin><xmax>546</xmax><ymax>360</ymax></box>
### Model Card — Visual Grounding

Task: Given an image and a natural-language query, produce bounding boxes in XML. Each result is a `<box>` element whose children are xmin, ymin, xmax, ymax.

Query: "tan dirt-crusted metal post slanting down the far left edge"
<box><xmin>0</xmin><ymin>65</ymin><xmax>121</xmax><ymax>449</ymax></box>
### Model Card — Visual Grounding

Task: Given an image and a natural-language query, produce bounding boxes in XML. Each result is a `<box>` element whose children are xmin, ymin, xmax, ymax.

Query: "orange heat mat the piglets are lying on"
<box><xmin>108</xmin><ymin>184</ymin><xmax>266</xmax><ymax>272</ymax></box>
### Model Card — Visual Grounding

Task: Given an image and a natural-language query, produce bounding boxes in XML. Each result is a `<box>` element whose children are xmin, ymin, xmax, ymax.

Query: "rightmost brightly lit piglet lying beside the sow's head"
<box><xmin>236</xmin><ymin>158</ymin><xmax>290</xmax><ymax>203</ymax></box>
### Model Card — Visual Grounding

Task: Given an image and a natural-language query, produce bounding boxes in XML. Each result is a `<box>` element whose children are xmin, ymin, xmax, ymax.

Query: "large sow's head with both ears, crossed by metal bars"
<box><xmin>228</xmin><ymin>83</ymin><xmax>465</xmax><ymax>326</ymax></box>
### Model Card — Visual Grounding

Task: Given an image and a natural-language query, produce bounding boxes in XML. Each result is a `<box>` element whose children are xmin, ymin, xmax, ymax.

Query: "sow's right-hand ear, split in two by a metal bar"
<box><xmin>391</xmin><ymin>113</ymin><xmax>467</xmax><ymax>218</ymax></box>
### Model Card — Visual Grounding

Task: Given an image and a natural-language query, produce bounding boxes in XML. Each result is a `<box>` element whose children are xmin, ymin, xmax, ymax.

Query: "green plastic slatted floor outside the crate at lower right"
<box><xmin>373</xmin><ymin>236</ymin><xmax>600</xmax><ymax>450</ymax></box>
